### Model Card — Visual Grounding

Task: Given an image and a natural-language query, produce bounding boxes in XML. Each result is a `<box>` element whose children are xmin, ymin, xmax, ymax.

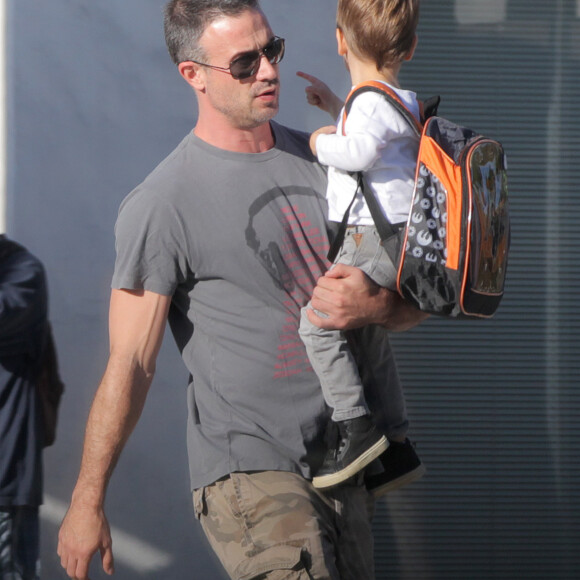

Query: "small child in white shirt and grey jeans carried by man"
<box><xmin>297</xmin><ymin>0</ymin><xmax>425</xmax><ymax>495</ymax></box>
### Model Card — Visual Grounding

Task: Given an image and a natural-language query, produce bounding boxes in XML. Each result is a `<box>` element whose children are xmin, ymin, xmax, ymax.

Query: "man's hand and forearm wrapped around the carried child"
<box><xmin>308</xmin><ymin>264</ymin><xmax>429</xmax><ymax>332</ymax></box>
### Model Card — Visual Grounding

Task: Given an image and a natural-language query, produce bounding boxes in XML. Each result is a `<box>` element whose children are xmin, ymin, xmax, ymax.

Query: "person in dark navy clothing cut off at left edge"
<box><xmin>0</xmin><ymin>235</ymin><xmax>47</xmax><ymax>580</ymax></box>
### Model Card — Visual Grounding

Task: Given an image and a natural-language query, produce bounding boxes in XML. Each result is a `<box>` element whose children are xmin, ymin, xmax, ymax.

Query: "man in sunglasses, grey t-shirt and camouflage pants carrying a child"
<box><xmin>59</xmin><ymin>0</ymin><xmax>421</xmax><ymax>580</ymax></box>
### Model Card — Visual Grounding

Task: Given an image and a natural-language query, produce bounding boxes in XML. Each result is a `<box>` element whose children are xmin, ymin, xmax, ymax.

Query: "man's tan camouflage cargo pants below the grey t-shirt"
<box><xmin>193</xmin><ymin>471</ymin><xmax>374</xmax><ymax>580</ymax></box>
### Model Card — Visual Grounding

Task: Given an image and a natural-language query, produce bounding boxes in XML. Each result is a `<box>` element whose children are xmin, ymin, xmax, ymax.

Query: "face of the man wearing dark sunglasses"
<box><xmin>200</xmin><ymin>10</ymin><xmax>280</xmax><ymax>129</ymax></box>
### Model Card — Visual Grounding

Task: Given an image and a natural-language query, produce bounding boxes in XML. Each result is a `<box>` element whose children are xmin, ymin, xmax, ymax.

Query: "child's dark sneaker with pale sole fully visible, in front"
<box><xmin>312</xmin><ymin>415</ymin><xmax>389</xmax><ymax>489</ymax></box>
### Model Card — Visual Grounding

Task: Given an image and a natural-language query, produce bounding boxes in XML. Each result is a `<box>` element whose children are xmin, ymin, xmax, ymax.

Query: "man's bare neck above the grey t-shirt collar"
<box><xmin>194</xmin><ymin>120</ymin><xmax>275</xmax><ymax>153</ymax></box>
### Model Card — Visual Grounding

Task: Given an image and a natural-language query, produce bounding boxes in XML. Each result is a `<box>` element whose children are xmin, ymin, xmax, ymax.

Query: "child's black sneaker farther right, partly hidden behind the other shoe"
<box><xmin>365</xmin><ymin>439</ymin><xmax>427</xmax><ymax>498</ymax></box>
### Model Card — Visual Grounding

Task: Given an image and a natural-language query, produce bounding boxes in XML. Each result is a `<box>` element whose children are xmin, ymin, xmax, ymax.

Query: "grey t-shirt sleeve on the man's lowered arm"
<box><xmin>111</xmin><ymin>188</ymin><xmax>188</xmax><ymax>296</ymax></box>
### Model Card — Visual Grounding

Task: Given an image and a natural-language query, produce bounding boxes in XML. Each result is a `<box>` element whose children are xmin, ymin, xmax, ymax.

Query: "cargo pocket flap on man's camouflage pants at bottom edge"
<box><xmin>234</xmin><ymin>544</ymin><xmax>312</xmax><ymax>580</ymax></box>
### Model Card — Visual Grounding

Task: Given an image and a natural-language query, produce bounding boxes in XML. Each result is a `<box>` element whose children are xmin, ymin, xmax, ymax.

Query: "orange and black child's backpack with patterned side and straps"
<box><xmin>329</xmin><ymin>81</ymin><xmax>510</xmax><ymax>318</ymax></box>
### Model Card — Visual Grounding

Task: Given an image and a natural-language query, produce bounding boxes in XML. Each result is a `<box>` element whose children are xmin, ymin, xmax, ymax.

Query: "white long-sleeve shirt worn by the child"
<box><xmin>316</xmin><ymin>83</ymin><xmax>419</xmax><ymax>225</ymax></box>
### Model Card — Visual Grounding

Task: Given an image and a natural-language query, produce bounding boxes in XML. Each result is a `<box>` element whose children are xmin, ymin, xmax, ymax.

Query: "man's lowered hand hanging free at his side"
<box><xmin>57</xmin><ymin>503</ymin><xmax>115</xmax><ymax>580</ymax></box>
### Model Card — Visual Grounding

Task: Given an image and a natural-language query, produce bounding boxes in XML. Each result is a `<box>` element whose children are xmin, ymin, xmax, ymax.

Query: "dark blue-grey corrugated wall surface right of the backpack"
<box><xmin>376</xmin><ymin>0</ymin><xmax>580</xmax><ymax>580</ymax></box>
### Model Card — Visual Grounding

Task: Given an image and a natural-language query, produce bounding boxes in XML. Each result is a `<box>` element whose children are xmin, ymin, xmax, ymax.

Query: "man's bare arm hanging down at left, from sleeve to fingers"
<box><xmin>58</xmin><ymin>290</ymin><xmax>171</xmax><ymax>580</ymax></box>
